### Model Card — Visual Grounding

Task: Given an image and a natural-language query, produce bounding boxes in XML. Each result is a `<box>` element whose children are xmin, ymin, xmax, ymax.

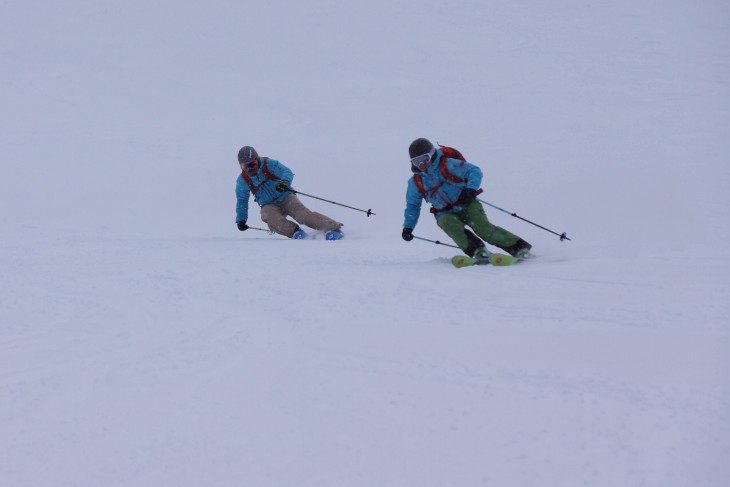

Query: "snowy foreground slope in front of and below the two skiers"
<box><xmin>0</xmin><ymin>230</ymin><xmax>730</xmax><ymax>486</ymax></box>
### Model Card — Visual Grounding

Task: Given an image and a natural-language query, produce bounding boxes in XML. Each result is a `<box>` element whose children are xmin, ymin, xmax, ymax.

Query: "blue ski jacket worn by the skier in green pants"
<box><xmin>403</xmin><ymin>150</ymin><xmax>483</xmax><ymax>228</ymax></box>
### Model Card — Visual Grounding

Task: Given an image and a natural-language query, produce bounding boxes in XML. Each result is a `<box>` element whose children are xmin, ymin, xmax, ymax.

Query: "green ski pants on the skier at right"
<box><xmin>436</xmin><ymin>201</ymin><xmax>520</xmax><ymax>251</ymax></box>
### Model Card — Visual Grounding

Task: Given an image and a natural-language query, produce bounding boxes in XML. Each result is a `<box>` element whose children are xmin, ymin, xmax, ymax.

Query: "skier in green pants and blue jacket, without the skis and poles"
<box><xmin>402</xmin><ymin>138</ymin><xmax>532</xmax><ymax>259</ymax></box>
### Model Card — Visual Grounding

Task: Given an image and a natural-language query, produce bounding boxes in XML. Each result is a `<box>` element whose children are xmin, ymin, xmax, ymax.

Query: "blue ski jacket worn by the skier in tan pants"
<box><xmin>236</xmin><ymin>157</ymin><xmax>294</xmax><ymax>222</ymax></box>
